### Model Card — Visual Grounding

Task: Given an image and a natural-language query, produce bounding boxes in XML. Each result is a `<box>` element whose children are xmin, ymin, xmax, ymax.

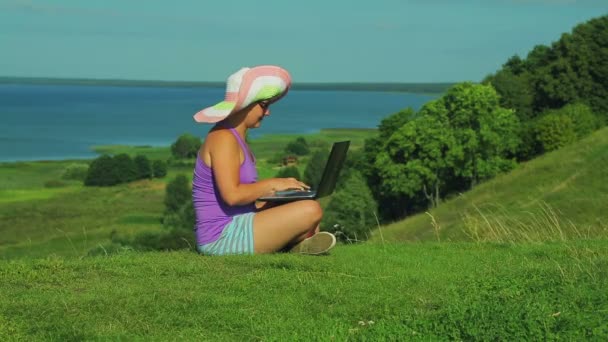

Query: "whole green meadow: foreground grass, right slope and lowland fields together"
<box><xmin>0</xmin><ymin>129</ymin><xmax>608</xmax><ymax>341</ymax></box>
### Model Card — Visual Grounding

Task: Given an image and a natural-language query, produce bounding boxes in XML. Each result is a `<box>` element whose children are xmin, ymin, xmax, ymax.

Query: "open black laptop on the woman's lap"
<box><xmin>258</xmin><ymin>140</ymin><xmax>350</xmax><ymax>202</ymax></box>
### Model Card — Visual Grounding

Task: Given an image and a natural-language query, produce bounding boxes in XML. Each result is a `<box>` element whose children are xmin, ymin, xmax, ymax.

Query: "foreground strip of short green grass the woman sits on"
<box><xmin>0</xmin><ymin>241</ymin><xmax>608</xmax><ymax>341</ymax></box>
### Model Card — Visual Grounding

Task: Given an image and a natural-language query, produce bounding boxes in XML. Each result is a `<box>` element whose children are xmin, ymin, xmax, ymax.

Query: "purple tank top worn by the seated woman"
<box><xmin>192</xmin><ymin>128</ymin><xmax>258</xmax><ymax>245</ymax></box>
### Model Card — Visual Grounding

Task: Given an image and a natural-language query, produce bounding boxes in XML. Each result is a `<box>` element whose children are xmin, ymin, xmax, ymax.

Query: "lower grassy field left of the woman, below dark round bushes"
<box><xmin>0</xmin><ymin>180</ymin><xmax>166</xmax><ymax>258</ymax></box>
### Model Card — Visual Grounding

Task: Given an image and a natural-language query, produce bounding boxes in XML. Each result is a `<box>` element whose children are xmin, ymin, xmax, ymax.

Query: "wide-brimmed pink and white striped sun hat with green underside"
<box><xmin>194</xmin><ymin>65</ymin><xmax>291</xmax><ymax>123</ymax></box>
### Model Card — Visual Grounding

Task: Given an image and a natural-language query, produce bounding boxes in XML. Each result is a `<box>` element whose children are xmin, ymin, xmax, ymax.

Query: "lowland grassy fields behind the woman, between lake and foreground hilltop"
<box><xmin>0</xmin><ymin>129</ymin><xmax>375</xmax><ymax>259</ymax></box>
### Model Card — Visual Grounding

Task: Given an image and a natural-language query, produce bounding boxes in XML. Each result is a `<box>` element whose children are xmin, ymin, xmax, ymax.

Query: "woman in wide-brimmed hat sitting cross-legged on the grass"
<box><xmin>192</xmin><ymin>65</ymin><xmax>336</xmax><ymax>255</ymax></box>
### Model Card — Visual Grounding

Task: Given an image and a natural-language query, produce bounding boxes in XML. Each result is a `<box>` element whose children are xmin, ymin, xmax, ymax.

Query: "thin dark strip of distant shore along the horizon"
<box><xmin>0</xmin><ymin>76</ymin><xmax>455</xmax><ymax>94</ymax></box>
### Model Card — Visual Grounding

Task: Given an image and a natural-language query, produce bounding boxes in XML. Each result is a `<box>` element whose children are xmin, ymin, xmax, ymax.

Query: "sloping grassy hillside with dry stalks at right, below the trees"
<box><xmin>374</xmin><ymin>128</ymin><xmax>608</xmax><ymax>242</ymax></box>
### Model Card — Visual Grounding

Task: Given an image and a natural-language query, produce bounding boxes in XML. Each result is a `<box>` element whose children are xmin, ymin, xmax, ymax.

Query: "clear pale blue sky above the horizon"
<box><xmin>0</xmin><ymin>0</ymin><xmax>608</xmax><ymax>82</ymax></box>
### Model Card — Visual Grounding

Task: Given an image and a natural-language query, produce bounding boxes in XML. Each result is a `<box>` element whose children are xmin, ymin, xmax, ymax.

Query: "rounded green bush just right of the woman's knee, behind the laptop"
<box><xmin>321</xmin><ymin>172</ymin><xmax>377</xmax><ymax>241</ymax></box>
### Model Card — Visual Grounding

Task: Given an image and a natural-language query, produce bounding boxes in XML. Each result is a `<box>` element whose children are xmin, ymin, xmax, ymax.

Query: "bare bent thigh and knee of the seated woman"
<box><xmin>253</xmin><ymin>200</ymin><xmax>323</xmax><ymax>254</ymax></box>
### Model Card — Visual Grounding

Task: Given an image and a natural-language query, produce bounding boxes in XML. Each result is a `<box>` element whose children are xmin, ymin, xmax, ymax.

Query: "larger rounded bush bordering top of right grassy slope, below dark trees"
<box><xmin>535</xmin><ymin>113</ymin><xmax>576</xmax><ymax>152</ymax></box>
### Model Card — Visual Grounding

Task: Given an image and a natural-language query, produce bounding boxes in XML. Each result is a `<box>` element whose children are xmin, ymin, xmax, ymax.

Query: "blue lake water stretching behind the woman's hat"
<box><xmin>0</xmin><ymin>84</ymin><xmax>434</xmax><ymax>161</ymax></box>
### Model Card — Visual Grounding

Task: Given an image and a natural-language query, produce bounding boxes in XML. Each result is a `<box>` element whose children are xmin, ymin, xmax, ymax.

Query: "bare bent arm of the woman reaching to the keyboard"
<box><xmin>208</xmin><ymin>131</ymin><xmax>308</xmax><ymax>206</ymax></box>
